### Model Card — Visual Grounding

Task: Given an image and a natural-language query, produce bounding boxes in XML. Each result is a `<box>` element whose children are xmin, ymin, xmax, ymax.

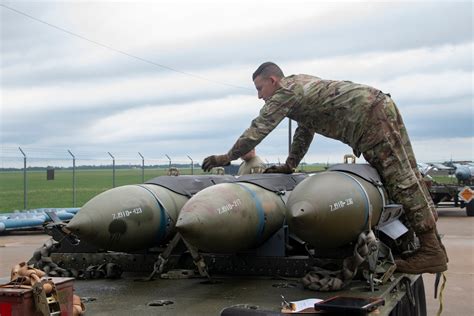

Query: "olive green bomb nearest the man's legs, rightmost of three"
<box><xmin>286</xmin><ymin>171</ymin><xmax>386</xmax><ymax>249</ymax></box>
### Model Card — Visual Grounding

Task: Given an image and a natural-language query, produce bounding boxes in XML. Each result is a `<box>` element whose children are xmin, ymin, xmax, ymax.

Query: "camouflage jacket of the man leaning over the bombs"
<box><xmin>228</xmin><ymin>75</ymin><xmax>385</xmax><ymax>167</ymax></box>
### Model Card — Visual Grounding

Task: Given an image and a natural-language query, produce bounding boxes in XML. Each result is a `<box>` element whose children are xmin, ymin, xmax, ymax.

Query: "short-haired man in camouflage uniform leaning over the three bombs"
<box><xmin>202</xmin><ymin>62</ymin><xmax>447</xmax><ymax>273</ymax></box>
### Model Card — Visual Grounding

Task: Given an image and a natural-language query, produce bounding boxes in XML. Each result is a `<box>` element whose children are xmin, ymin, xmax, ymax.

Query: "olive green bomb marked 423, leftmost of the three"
<box><xmin>66</xmin><ymin>184</ymin><xmax>189</xmax><ymax>251</ymax></box>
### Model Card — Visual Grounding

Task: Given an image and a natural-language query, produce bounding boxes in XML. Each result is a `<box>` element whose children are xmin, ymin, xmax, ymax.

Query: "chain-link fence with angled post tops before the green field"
<box><xmin>0</xmin><ymin>147</ymin><xmax>207</xmax><ymax>212</ymax></box>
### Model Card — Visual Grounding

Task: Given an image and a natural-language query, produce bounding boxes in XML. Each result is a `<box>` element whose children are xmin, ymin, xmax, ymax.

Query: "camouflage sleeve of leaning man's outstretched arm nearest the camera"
<box><xmin>227</xmin><ymin>89</ymin><xmax>296</xmax><ymax>160</ymax></box>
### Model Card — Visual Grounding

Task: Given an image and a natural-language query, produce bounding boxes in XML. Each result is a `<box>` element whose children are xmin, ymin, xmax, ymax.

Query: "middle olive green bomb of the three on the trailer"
<box><xmin>176</xmin><ymin>182</ymin><xmax>286</xmax><ymax>253</ymax></box>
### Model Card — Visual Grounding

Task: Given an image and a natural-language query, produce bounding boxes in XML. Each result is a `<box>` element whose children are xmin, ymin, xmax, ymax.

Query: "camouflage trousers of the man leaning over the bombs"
<box><xmin>363</xmin><ymin>96</ymin><xmax>437</xmax><ymax>234</ymax></box>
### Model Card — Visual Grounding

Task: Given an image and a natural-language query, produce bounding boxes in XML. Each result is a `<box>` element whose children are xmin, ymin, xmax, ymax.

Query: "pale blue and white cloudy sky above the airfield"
<box><xmin>0</xmin><ymin>0</ymin><xmax>474</xmax><ymax>166</ymax></box>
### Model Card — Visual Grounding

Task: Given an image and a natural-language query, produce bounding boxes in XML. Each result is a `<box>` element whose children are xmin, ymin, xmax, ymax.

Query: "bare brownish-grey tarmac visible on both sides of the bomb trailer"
<box><xmin>0</xmin><ymin>207</ymin><xmax>474</xmax><ymax>315</ymax></box>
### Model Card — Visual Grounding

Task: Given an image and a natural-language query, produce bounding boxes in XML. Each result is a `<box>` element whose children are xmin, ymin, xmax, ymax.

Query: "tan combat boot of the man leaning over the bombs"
<box><xmin>395</xmin><ymin>229</ymin><xmax>448</xmax><ymax>274</ymax></box>
